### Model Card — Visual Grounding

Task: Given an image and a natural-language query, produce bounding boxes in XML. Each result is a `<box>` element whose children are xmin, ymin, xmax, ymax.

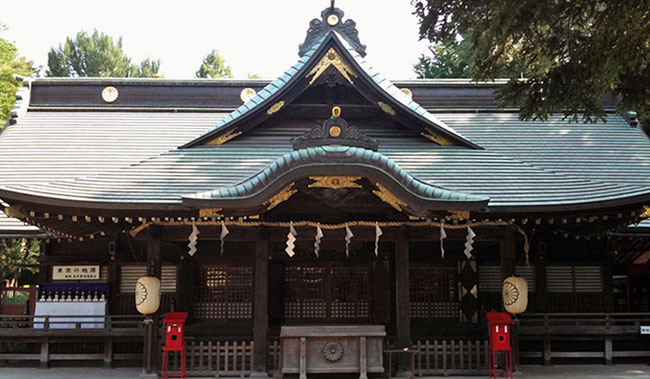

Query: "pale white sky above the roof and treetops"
<box><xmin>0</xmin><ymin>0</ymin><xmax>427</xmax><ymax>80</ymax></box>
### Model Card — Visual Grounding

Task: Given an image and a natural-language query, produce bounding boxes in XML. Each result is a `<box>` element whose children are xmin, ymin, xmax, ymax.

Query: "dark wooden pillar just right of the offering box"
<box><xmin>395</xmin><ymin>227</ymin><xmax>411</xmax><ymax>378</ymax></box>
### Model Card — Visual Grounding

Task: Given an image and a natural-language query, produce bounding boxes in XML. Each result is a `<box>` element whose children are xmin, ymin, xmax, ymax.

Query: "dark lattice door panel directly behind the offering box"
<box><xmin>284</xmin><ymin>262</ymin><xmax>370</xmax><ymax>322</ymax></box>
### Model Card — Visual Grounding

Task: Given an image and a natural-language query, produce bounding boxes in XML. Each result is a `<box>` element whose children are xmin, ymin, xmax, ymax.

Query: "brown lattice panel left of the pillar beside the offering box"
<box><xmin>194</xmin><ymin>265</ymin><xmax>253</xmax><ymax>321</ymax></box>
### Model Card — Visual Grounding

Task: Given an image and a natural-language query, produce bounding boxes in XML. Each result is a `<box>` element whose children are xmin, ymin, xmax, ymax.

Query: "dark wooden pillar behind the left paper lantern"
<box><xmin>140</xmin><ymin>225</ymin><xmax>162</xmax><ymax>378</ymax></box>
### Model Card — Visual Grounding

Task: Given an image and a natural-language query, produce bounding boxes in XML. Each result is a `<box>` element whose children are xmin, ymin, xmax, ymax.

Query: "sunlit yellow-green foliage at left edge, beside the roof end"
<box><xmin>0</xmin><ymin>38</ymin><xmax>35</xmax><ymax>124</ymax></box>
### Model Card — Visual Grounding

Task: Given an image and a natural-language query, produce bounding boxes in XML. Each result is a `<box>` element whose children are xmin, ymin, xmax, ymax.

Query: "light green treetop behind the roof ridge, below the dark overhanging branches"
<box><xmin>413</xmin><ymin>38</ymin><xmax>474</xmax><ymax>79</ymax></box>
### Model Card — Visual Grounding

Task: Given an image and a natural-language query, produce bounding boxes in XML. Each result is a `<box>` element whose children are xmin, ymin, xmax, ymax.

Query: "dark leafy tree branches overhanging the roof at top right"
<box><xmin>412</xmin><ymin>0</ymin><xmax>650</xmax><ymax>121</ymax></box>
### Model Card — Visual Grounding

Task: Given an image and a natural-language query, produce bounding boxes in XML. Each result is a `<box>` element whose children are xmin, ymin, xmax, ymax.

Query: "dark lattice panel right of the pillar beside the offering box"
<box><xmin>409</xmin><ymin>263</ymin><xmax>460</xmax><ymax>319</ymax></box>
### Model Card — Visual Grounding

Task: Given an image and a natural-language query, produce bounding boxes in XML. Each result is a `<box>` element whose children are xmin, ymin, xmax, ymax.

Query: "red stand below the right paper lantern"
<box><xmin>487</xmin><ymin>312</ymin><xmax>512</xmax><ymax>379</ymax></box>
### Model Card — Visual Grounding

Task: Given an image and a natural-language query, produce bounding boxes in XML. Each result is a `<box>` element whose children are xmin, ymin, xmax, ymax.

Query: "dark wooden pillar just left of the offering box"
<box><xmin>250</xmin><ymin>228</ymin><xmax>270</xmax><ymax>378</ymax></box>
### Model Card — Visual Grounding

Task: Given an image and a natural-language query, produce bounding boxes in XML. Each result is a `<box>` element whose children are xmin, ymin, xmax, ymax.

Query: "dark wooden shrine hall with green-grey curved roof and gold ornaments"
<box><xmin>0</xmin><ymin>6</ymin><xmax>650</xmax><ymax>377</ymax></box>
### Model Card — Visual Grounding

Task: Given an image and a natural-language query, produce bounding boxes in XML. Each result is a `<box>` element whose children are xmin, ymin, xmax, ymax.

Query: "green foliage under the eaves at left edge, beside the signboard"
<box><xmin>0</xmin><ymin>238</ymin><xmax>40</xmax><ymax>282</ymax></box>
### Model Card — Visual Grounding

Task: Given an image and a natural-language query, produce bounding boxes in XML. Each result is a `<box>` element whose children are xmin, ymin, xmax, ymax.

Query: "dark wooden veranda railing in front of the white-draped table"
<box><xmin>0</xmin><ymin>315</ymin><xmax>144</xmax><ymax>367</ymax></box>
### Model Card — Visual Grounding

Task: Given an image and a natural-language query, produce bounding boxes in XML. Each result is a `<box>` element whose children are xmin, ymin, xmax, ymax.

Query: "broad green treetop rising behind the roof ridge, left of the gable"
<box><xmin>46</xmin><ymin>30</ymin><xmax>160</xmax><ymax>78</ymax></box>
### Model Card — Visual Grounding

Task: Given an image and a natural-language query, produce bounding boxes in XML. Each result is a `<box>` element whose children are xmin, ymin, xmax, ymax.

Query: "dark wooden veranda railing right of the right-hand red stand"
<box><xmin>519</xmin><ymin>313</ymin><xmax>650</xmax><ymax>364</ymax></box>
